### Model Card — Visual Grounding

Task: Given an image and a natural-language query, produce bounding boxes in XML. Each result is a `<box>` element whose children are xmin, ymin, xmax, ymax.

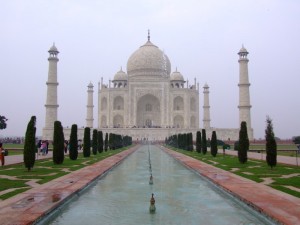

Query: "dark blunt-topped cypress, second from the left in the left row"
<box><xmin>52</xmin><ymin>121</ymin><xmax>65</xmax><ymax>164</ymax></box>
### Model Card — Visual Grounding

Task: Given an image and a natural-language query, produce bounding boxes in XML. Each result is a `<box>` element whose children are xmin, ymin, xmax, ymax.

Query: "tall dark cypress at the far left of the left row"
<box><xmin>23</xmin><ymin>116</ymin><xmax>36</xmax><ymax>171</ymax></box>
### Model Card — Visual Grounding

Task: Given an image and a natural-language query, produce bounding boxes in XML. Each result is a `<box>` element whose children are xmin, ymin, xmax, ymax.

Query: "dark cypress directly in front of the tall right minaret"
<box><xmin>238</xmin><ymin>121</ymin><xmax>249</xmax><ymax>164</ymax></box>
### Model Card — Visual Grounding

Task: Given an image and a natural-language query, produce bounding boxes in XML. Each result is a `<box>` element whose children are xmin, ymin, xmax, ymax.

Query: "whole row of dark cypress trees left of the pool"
<box><xmin>23</xmin><ymin>116</ymin><xmax>132</xmax><ymax>171</ymax></box>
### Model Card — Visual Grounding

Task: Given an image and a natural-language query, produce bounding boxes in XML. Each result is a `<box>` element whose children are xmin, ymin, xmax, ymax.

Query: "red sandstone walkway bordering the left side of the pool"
<box><xmin>0</xmin><ymin>145</ymin><xmax>140</xmax><ymax>225</ymax></box>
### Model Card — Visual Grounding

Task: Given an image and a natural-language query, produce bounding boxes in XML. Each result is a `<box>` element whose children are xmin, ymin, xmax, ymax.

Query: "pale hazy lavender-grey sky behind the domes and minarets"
<box><xmin>0</xmin><ymin>0</ymin><xmax>300</xmax><ymax>138</ymax></box>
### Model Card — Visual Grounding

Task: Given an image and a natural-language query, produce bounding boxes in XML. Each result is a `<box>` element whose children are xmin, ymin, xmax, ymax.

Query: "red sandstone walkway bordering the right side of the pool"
<box><xmin>159</xmin><ymin>146</ymin><xmax>300</xmax><ymax>225</ymax></box>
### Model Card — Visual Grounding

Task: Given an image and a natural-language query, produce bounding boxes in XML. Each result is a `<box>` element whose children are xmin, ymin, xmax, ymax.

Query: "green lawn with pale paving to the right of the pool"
<box><xmin>169</xmin><ymin>147</ymin><xmax>300</xmax><ymax>198</ymax></box>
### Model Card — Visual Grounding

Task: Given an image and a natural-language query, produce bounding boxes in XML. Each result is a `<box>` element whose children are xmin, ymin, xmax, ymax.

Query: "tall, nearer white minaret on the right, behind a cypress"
<box><xmin>238</xmin><ymin>46</ymin><xmax>253</xmax><ymax>140</ymax></box>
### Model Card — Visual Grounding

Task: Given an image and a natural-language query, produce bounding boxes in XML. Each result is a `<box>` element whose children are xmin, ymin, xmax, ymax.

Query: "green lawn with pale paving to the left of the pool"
<box><xmin>0</xmin><ymin>147</ymin><xmax>128</xmax><ymax>200</ymax></box>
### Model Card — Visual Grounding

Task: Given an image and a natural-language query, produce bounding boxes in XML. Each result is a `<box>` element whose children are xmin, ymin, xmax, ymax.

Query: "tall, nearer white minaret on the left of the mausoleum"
<box><xmin>43</xmin><ymin>43</ymin><xmax>59</xmax><ymax>140</ymax></box>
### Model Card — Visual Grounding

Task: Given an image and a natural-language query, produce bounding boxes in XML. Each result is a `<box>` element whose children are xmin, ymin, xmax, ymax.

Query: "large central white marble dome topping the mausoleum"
<box><xmin>127</xmin><ymin>37</ymin><xmax>171</xmax><ymax>77</ymax></box>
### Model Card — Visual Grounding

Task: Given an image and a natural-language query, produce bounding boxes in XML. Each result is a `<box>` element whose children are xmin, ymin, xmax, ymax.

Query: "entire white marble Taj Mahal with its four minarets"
<box><xmin>43</xmin><ymin>32</ymin><xmax>253</xmax><ymax>141</ymax></box>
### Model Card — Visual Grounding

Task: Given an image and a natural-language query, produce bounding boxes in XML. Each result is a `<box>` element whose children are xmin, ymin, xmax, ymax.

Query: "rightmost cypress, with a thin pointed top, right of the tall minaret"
<box><xmin>265</xmin><ymin>116</ymin><xmax>277</xmax><ymax>169</ymax></box>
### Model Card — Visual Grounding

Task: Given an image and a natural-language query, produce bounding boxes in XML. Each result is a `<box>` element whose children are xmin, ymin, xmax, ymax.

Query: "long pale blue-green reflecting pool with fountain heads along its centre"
<box><xmin>44</xmin><ymin>145</ymin><xmax>273</xmax><ymax>225</ymax></box>
